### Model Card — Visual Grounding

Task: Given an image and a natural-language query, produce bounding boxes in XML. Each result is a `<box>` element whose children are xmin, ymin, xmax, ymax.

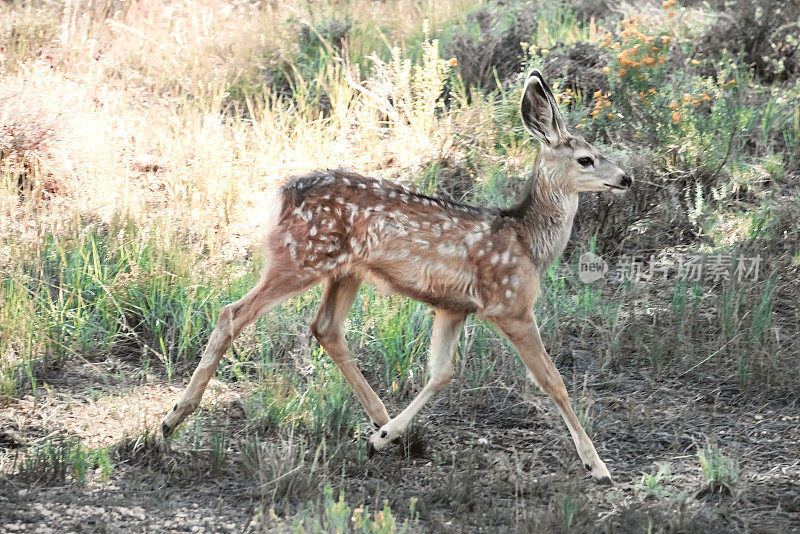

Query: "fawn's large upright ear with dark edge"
<box><xmin>519</xmin><ymin>69</ymin><xmax>567</xmax><ymax>146</ymax></box>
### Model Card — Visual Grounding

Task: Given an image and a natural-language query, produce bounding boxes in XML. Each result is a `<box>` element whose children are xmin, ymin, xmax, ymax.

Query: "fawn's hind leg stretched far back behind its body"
<box><xmin>161</xmin><ymin>268</ymin><xmax>318</xmax><ymax>438</ymax></box>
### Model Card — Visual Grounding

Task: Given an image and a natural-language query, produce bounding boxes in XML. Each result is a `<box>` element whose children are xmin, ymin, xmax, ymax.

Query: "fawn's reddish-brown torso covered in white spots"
<box><xmin>267</xmin><ymin>170</ymin><xmax>538</xmax><ymax>315</ymax></box>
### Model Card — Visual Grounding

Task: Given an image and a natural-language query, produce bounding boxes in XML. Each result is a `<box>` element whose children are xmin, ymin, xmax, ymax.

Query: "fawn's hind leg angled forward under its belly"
<box><xmin>311</xmin><ymin>276</ymin><xmax>389</xmax><ymax>427</ymax></box>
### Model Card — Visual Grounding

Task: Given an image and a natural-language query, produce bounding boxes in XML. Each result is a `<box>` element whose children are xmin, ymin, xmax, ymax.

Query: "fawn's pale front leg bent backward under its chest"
<box><xmin>369</xmin><ymin>309</ymin><xmax>466</xmax><ymax>451</ymax></box>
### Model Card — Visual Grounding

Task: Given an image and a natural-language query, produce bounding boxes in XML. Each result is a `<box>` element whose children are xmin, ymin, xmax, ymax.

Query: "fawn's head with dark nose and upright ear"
<box><xmin>520</xmin><ymin>69</ymin><xmax>633</xmax><ymax>193</ymax></box>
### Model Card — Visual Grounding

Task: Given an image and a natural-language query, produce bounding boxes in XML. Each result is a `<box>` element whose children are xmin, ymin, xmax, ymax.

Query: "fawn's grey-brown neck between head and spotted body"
<box><xmin>511</xmin><ymin>165</ymin><xmax>578</xmax><ymax>270</ymax></box>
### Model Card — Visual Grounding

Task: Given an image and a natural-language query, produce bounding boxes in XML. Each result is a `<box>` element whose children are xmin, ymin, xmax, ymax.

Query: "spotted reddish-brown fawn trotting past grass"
<box><xmin>162</xmin><ymin>69</ymin><xmax>632</xmax><ymax>484</ymax></box>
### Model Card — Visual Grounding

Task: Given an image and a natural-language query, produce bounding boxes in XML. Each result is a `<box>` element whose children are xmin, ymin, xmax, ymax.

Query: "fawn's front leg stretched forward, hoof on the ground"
<box><xmin>492</xmin><ymin>315</ymin><xmax>612</xmax><ymax>484</ymax></box>
